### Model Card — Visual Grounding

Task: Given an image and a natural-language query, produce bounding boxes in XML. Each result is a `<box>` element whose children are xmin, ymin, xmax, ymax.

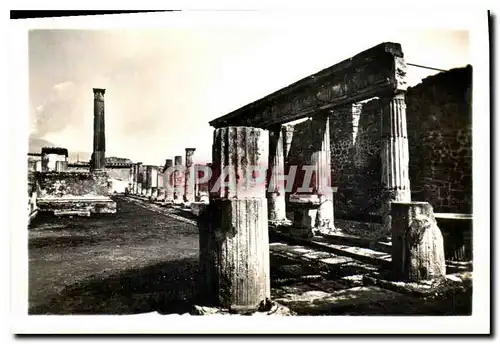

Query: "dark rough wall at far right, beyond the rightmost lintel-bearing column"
<box><xmin>406</xmin><ymin>66</ymin><xmax>472</xmax><ymax>213</ymax></box>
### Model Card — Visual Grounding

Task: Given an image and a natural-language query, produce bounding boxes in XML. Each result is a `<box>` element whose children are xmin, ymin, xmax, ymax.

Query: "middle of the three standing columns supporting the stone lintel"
<box><xmin>311</xmin><ymin>113</ymin><xmax>335</xmax><ymax>231</ymax></box>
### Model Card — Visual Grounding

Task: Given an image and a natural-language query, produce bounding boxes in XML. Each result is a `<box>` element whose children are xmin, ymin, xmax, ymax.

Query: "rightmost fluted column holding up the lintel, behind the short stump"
<box><xmin>381</xmin><ymin>92</ymin><xmax>411</xmax><ymax>233</ymax></box>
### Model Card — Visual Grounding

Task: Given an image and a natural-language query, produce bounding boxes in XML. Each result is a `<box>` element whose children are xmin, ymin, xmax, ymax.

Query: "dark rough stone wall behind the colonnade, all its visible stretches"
<box><xmin>285</xmin><ymin>67</ymin><xmax>472</xmax><ymax>218</ymax></box>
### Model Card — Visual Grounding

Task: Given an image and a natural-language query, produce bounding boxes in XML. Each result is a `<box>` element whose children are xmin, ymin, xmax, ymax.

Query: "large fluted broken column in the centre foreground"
<box><xmin>200</xmin><ymin>127</ymin><xmax>270</xmax><ymax>312</ymax></box>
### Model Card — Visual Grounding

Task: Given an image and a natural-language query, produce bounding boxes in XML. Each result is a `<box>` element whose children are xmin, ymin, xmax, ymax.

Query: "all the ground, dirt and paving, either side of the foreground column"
<box><xmin>29</xmin><ymin>197</ymin><xmax>471</xmax><ymax>315</ymax></box>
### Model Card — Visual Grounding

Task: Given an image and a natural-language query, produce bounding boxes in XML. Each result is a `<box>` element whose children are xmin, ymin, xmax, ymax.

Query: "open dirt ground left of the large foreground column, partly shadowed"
<box><xmin>29</xmin><ymin>197</ymin><xmax>198</xmax><ymax>314</ymax></box>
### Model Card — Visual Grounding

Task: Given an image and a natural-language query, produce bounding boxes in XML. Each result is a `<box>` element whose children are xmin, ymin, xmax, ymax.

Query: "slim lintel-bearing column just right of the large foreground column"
<box><xmin>266</xmin><ymin>125</ymin><xmax>289</xmax><ymax>224</ymax></box>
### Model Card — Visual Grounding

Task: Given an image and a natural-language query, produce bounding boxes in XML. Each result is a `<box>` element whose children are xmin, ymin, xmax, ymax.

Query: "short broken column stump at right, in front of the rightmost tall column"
<box><xmin>391</xmin><ymin>202</ymin><xmax>446</xmax><ymax>282</ymax></box>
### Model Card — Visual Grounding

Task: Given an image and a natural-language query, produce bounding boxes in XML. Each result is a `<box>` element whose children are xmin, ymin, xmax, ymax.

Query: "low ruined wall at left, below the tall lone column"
<box><xmin>35</xmin><ymin>172</ymin><xmax>108</xmax><ymax>198</ymax></box>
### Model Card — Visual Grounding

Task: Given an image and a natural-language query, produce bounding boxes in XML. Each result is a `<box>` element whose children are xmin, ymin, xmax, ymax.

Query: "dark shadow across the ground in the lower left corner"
<box><xmin>28</xmin><ymin>259</ymin><xmax>198</xmax><ymax>314</ymax></box>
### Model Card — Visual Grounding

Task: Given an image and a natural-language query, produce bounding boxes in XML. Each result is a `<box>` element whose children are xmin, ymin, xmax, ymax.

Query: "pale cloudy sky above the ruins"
<box><xmin>29</xmin><ymin>24</ymin><xmax>471</xmax><ymax>164</ymax></box>
